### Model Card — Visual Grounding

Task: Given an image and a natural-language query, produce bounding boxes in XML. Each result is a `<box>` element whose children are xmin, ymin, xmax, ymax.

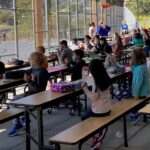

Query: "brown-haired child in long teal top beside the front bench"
<box><xmin>130</xmin><ymin>48</ymin><xmax>150</xmax><ymax>121</ymax></box>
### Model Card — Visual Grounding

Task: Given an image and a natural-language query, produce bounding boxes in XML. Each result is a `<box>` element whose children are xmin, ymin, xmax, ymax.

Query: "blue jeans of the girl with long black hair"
<box><xmin>81</xmin><ymin>108</ymin><xmax>111</xmax><ymax>121</ymax></box>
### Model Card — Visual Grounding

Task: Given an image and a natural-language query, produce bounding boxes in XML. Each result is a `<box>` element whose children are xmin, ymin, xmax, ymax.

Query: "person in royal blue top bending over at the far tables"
<box><xmin>97</xmin><ymin>22</ymin><xmax>111</xmax><ymax>37</ymax></box>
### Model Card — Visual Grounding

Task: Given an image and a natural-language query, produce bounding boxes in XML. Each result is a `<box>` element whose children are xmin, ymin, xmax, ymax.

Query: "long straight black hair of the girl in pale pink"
<box><xmin>89</xmin><ymin>59</ymin><xmax>111</xmax><ymax>91</ymax></box>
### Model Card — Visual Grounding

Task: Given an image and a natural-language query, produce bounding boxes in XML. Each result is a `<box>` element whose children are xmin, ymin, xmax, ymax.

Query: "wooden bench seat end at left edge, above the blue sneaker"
<box><xmin>0</xmin><ymin>108</ymin><xmax>24</xmax><ymax>124</ymax></box>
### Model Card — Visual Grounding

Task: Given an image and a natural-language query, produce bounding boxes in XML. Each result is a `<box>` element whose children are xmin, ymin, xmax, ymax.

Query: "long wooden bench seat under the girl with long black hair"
<box><xmin>49</xmin><ymin>100</ymin><xmax>142</xmax><ymax>145</ymax></box>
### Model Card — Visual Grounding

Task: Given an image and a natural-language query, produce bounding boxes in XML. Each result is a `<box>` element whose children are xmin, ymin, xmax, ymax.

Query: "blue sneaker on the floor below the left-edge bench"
<box><xmin>8</xmin><ymin>124</ymin><xmax>23</xmax><ymax>137</ymax></box>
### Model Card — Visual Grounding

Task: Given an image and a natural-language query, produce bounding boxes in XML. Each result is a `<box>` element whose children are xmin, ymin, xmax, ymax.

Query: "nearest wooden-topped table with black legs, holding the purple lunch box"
<box><xmin>10</xmin><ymin>71</ymin><xmax>130</xmax><ymax>150</ymax></box>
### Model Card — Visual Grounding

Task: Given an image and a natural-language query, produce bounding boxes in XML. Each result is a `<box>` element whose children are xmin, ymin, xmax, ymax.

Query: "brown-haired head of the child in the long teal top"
<box><xmin>131</xmin><ymin>47</ymin><xmax>146</xmax><ymax>65</ymax></box>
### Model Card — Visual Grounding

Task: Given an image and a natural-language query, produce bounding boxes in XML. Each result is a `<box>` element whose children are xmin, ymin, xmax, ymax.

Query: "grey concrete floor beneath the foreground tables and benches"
<box><xmin>0</xmin><ymin>98</ymin><xmax>150</xmax><ymax>150</ymax></box>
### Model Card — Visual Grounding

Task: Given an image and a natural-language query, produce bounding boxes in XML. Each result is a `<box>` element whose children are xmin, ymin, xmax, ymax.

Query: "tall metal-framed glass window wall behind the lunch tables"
<box><xmin>0</xmin><ymin>0</ymin><xmax>123</xmax><ymax>62</ymax></box>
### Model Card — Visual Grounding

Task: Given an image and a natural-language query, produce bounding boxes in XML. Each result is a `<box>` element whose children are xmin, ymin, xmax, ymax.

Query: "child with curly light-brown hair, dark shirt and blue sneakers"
<box><xmin>6</xmin><ymin>52</ymin><xmax>48</xmax><ymax>137</ymax></box>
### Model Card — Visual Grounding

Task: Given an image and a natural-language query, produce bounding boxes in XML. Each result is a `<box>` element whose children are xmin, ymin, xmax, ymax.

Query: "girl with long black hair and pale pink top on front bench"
<box><xmin>81</xmin><ymin>59</ymin><xmax>111</xmax><ymax>150</ymax></box>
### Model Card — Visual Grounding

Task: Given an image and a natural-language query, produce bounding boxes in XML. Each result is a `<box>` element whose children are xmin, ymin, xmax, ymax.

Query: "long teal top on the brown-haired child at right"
<box><xmin>132</xmin><ymin>63</ymin><xmax>150</xmax><ymax>97</ymax></box>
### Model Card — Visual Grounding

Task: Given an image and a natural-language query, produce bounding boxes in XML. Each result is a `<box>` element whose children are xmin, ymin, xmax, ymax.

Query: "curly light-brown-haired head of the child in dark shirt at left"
<box><xmin>29</xmin><ymin>52</ymin><xmax>45</xmax><ymax>68</ymax></box>
